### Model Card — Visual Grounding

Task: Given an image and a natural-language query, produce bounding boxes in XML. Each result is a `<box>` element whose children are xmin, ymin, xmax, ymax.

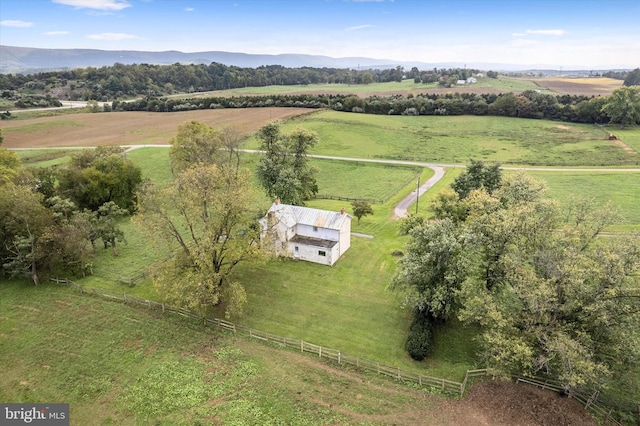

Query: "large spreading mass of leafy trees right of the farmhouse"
<box><xmin>394</xmin><ymin>173</ymin><xmax>640</xmax><ymax>390</ymax></box>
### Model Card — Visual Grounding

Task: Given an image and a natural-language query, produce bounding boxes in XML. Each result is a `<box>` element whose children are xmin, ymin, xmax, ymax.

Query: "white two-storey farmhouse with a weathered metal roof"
<box><xmin>259</xmin><ymin>200</ymin><xmax>352</xmax><ymax>265</ymax></box>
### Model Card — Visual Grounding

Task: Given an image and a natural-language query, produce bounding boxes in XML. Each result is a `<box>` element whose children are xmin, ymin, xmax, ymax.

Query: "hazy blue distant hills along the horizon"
<box><xmin>0</xmin><ymin>45</ymin><xmax>624</xmax><ymax>74</ymax></box>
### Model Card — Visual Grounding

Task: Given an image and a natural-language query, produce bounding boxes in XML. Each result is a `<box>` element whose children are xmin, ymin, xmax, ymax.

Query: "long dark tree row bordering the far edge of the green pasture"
<box><xmin>97</xmin><ymin>86</ymin><xmax>640</xmax><ymax>125</ymax></box>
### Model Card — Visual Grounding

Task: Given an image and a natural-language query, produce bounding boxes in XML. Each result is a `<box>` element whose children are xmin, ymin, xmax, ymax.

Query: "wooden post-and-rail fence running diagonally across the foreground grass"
<box><xmin>51</xmin><ymin>278</ymin><xmax>622</xmax><ymax>426</ymax></box>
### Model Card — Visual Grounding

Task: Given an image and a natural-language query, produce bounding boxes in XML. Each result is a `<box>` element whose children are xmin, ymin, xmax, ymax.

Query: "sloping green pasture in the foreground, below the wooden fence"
<box><xmin>0</xmin><ymin>282</ymin><xmax>448</xmax><ymax>425</ymax></box>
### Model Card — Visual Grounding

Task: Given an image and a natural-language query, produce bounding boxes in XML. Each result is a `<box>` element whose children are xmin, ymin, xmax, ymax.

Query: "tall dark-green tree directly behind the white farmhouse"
<box><xmin>257</xmin><ymin>123</ymin><xmax>318</xmax><ymax>205</ymax></box>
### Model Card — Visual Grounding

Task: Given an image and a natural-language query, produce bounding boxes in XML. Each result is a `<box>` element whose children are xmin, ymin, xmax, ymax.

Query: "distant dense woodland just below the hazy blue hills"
<box><xmin>0</xmin><ymin>62</ymin><xmax>484</xmax><ymax>102</ymax></box>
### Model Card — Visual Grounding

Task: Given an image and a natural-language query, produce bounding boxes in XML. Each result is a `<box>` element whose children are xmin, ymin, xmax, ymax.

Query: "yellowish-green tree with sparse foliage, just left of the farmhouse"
<box><xmin>135</xmin><ymin>163</ymin><xmax>260</xmax><ymax>316</ymax></box>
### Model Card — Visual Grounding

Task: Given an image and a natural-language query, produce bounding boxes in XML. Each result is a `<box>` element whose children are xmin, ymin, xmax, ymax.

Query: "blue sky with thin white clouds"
<box><xmin>0</xmin><ymin>0</ymin><xmax>640</xmax><ymax>69</ymax></box>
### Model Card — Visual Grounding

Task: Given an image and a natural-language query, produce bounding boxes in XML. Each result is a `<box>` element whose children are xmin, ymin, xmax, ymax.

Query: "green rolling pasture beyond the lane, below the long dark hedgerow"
<box><xmin>242</xmin><ymin>111</ymin><xmax>640</xmax><ymax>167</ymax></box>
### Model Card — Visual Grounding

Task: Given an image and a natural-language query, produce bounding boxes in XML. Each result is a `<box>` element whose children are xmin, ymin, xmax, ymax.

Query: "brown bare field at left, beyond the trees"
<box><xmin>0</xmin><ymin>108</ymin><xmax>315</xmax><ymax>148</ymax></box>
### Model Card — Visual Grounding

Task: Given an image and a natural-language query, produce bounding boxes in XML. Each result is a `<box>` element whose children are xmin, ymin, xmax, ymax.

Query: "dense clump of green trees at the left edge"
<box><xmin>0</xmin><ymin>141</ymin><xmax>142</xmax><ymax>285</ymax></box>
